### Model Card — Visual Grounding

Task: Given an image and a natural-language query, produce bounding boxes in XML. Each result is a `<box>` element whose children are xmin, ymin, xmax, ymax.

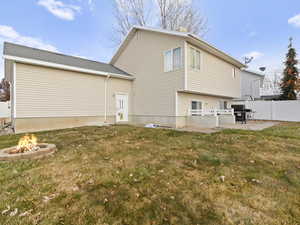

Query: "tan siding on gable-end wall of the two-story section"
<box><xmin>115</xmin><ymin>31</ymin><xmax>184</xmax><ymax>116</ymax></box>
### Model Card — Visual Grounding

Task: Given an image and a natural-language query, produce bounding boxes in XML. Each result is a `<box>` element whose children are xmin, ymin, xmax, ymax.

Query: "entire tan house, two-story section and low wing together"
<box><xmin>4</xmin><ymin>27</ymin><xmax>244</xmax><ymax>132</ymax></box>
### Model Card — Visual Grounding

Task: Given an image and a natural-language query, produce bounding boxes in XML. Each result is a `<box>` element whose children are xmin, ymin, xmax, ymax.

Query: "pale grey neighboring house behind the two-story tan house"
<box><xmin>240</xmin><ymin>69</ymin><xmax>265</xmax><ymax>100</ymax></box>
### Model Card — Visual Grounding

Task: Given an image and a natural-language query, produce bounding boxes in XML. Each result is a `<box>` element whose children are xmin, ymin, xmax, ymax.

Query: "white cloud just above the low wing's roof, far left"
<box><xmin>0</xmin><ymin>25</ymin><xmax>58</xmax><ymax>79</ymax></box>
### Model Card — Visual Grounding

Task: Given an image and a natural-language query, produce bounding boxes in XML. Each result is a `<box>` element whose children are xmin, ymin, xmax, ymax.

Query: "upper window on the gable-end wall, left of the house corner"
<box><xmin>164</xmin><ymin>48</ymin><xmax>182</xmax><ymax>72</ymax></box>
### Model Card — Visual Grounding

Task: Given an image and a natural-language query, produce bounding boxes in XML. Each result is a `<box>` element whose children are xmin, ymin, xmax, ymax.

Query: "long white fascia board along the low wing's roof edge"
<box><xmin>3</xmin><ymin>55</ymin><xmax>134</xmax><ymax>80</ymax></box>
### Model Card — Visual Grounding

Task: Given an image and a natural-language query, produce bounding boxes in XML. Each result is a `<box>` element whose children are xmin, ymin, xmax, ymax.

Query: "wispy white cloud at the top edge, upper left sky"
<box><xmin>38</xmin><ymin>0</ymin><xmax>81</xmax><ymax>20</ymax></box>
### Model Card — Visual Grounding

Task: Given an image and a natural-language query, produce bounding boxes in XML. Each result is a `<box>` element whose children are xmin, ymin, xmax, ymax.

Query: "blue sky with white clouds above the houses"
<box><xmin>0</xmin><ymin>0</ymin><xmax>300</xmax><ymax>78</ymax></box>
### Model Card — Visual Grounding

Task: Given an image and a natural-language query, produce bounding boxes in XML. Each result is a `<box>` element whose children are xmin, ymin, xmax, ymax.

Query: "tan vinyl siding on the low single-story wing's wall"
<box><xmin>16</xmin><ymin>63</ymin><xmax>130</xmax><ymax>118</ymax></box>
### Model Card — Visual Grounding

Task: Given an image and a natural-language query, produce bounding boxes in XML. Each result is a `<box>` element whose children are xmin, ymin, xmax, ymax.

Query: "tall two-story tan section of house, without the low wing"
<box><xmin>110</xmin><ymin>27</ymin><xmax>244</xmax><ymax>127</ymax></box>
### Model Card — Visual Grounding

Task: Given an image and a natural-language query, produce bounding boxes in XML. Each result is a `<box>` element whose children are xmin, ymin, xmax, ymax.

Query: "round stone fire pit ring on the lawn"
<box><xmin>0</xmin><ymin>143</ymin><xmax>57</xmax><ymax>161</ymax></box>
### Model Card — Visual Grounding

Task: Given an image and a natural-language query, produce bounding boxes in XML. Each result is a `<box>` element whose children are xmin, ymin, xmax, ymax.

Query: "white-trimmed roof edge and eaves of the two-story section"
<box><xmin>110</xmin><ymin>26</ymin><xmax>246</xmax><ymax>68</ymax></box>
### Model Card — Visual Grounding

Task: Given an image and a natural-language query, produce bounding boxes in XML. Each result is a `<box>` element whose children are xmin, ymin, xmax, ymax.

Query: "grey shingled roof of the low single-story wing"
<box><xmin>3</xmin><ymin>42</ymin><xmax>133</xmax><ymax>78</ymax></box>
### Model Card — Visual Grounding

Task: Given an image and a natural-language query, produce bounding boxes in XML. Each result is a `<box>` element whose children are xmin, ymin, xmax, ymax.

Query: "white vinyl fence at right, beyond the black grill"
<box><xmin>235</xmin><ymin>101</ymin><xmax>300</xmax><ymax>122</ymax></box>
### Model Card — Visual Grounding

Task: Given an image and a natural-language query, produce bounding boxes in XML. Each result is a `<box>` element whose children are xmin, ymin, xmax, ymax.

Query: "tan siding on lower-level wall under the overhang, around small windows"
<box><xmin>177</xmin><ymin>93</ymin><xmax>231</xmax><ymax>116</ymax></box>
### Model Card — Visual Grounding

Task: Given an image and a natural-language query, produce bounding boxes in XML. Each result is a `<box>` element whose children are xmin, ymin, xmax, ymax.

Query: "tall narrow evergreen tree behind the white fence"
<box><xmin>280</xmin><ymin>38</ymin><xmax>299</xmax><ymax>100</ymax></box>
